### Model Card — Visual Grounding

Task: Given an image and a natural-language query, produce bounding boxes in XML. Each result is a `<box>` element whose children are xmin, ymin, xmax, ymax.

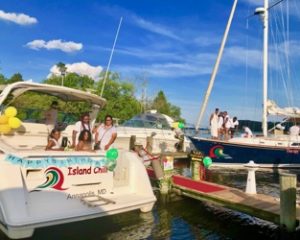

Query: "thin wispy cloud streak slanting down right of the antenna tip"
<box><xmin>132</xmin><ymin>15</ymin><xmax>181</xmax><ymax>40</ymax></box>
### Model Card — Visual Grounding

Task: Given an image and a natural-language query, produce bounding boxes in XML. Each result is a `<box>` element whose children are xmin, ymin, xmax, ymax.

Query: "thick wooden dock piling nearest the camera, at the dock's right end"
<box><xmin>280</xmin><ymin>173</ymin><xmax>297</xmax><ymax>232</ymax></box>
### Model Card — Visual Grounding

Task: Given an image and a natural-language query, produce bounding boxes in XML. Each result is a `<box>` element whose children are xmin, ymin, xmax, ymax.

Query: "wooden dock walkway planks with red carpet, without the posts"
<box><xmin>172</xmin><ymin>175</ymin><xmax>300</xmax><ymax>224</ymax></box>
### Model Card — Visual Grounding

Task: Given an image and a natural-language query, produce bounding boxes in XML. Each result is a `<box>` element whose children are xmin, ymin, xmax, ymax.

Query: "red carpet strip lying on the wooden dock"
<box><xmin>172</xmin><ymin>175</ymin><xmax>226</xmax><ymax>193</ymax></box>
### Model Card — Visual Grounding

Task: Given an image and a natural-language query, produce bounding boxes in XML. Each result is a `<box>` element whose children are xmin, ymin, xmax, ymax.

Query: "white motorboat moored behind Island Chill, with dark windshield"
<box><xmin>115</xmin><ymin>110</ymin><xmax>191</xmax><ymax>153</ymax></box>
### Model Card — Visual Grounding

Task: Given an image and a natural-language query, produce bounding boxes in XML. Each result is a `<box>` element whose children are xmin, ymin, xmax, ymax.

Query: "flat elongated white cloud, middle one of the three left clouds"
<box><xmin>26</xmin><ymin>39</ymin><xmax>83</xmax><ymax>52</ymax></box>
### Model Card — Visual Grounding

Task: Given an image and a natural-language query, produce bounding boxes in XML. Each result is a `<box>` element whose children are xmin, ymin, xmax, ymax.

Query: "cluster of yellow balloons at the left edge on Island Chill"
<box><xmin>0</xmin><ymin>107</ymin><xmax>22</xmax><ymax>134</ymax></box>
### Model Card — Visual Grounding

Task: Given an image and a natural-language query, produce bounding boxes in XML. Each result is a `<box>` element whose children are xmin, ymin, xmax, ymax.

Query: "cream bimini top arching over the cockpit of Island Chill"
<box><xmin>0</xmin><ymin>82</ymin><xmax>106</xmax><ymax>108</ymax></box>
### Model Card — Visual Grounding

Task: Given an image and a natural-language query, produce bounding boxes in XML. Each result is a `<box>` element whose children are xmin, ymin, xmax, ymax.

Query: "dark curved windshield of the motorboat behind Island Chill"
<box><xmin>122</xmin><ymin>113</ymin><xmax>171</xmax><ymax>129</ymax></box>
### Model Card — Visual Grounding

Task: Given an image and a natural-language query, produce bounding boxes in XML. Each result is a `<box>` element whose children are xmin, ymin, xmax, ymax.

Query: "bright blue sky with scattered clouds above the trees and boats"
<box><xmin>0</xmin><ymin>0</ymin><xmax>300</xmax><ymax>126</ymax></box>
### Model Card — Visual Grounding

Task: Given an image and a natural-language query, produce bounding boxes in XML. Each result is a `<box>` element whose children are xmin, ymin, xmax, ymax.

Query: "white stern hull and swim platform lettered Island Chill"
<box><xmin>0</xmin><ymin>151</ymin><xmax>156</xmax><ymax>239</ymax></box>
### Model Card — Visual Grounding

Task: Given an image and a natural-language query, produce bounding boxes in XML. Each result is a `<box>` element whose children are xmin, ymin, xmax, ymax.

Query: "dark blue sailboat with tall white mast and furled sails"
<box><xmin>190</xmin><ymin>0</ymin><xmax>300</xmax><ymax>168</ymax></box>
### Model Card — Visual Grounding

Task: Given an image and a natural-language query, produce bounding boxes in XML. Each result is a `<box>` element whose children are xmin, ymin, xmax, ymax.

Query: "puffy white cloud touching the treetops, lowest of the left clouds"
<box><xmin>48</xmin><ymin>62</ymin><xmax>103</xmax><ymax>80</ymax></box>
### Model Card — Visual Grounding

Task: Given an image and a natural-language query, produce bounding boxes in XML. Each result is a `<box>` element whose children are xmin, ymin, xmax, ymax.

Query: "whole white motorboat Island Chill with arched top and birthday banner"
<box><xmin>0</xmin><ymin>82</ymin><xmax>156</xmax><ymax>239</ymax></box>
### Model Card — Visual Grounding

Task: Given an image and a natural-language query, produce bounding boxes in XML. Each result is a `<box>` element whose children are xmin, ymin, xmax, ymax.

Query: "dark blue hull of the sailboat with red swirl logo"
<box><xmin>190</xmin><ymin>137</ymin><xmax>300</xmax><ymax>168</ymax></box>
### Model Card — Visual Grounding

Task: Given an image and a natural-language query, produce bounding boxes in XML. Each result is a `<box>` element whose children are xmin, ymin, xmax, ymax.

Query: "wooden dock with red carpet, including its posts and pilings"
<box><xmin>147</xmin><ymin>154</ymin><xmax>300</xmax><ymax>232</ymax></box>
